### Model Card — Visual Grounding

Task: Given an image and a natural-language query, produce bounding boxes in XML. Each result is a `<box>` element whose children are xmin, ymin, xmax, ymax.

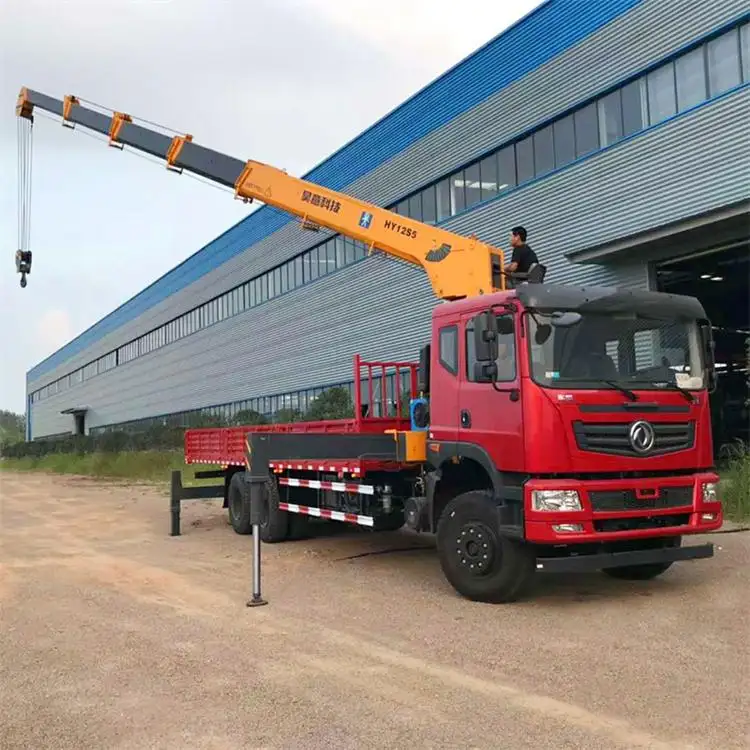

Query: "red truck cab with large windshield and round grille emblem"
<box><xmin>421</xmin><ymin>284</ymin><xmax>722</xmax><ymax>598</ymax></box>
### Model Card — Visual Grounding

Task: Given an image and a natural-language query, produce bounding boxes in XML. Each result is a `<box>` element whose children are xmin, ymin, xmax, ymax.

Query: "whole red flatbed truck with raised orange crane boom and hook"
<box><xmin>16</xmin><ymin>88</ymin><xmax>722</xmax><ymax>601</ymax></box>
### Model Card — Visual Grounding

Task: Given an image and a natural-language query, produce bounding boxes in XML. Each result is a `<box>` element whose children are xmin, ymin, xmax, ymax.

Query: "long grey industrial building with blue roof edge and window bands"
<box><xmin>27</xmin><ymin>0</ymin><xmax>750</xmax><ymax>456</ymax></box>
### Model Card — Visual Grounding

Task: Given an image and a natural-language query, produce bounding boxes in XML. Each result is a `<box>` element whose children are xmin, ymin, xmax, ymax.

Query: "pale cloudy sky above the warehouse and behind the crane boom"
<box><xmin>0</xmin><ymin>0</ymin><xmax>541</xmax><ymax>413</ymax></box>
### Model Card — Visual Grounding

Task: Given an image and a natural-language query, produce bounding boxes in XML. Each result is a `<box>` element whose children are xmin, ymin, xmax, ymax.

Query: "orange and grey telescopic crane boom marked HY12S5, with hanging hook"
<box><xmin>16</xmin><ymin>88</ymin><xmax>505</xmax><ymax>300</ymax></box>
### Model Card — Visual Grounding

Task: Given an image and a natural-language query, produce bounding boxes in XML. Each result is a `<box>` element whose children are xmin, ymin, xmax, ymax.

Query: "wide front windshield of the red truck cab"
<box><xmin>527</xmin><ymin>312</ymin><xmax>705</xmax><ymax>390</ymax></box>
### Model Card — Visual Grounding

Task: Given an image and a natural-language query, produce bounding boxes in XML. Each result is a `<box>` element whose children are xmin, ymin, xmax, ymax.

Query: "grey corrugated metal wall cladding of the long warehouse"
<box><xmin>26</xmin><ymin>1</ymin><xmax>748</xmax><ymax>436</ymax></box>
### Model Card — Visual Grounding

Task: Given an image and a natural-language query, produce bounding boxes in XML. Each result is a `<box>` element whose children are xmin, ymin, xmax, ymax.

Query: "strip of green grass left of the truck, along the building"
<box><xmin>0</xmin><ymin>451</ymin><xmax>219</xmax><ymax>485</ymax></box>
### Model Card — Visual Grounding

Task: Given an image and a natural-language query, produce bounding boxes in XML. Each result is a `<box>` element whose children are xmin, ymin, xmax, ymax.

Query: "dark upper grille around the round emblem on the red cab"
<box><xmin>573</xmin><ymin>422</ymin><xmax>695</xmax><ymax>458</ymax></box>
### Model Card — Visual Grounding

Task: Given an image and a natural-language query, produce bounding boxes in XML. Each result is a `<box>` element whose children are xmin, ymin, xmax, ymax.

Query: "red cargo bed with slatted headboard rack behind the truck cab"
<box><xmin>185</xmin><ymin>355</ymin><xmax>417</xmax><ymax>473</ymax></box>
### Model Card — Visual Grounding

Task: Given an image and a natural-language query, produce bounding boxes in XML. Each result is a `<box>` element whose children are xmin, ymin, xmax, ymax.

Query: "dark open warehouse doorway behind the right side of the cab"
<box><xmin>655</xmin><ymin>241</ymin><xmax>750</xmax><ymax>457</ymax></box>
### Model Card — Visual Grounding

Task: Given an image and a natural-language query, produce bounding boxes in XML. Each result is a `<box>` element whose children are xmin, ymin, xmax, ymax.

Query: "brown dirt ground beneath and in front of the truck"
<box><xmin>0</xmin><ymin>473</ymin><xmax>750</xmax><ymax>750</ymax></box>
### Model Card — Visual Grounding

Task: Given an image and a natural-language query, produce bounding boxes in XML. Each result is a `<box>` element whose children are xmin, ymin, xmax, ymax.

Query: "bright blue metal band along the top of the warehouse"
<box><xmin>26</xmin><ymin>0</ymin><xmax>642</xmax><ymax>382</ymax></box>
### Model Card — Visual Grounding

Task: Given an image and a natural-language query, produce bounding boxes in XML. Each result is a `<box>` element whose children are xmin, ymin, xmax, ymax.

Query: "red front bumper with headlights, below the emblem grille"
<box><xmin>524</xmin><ymin>472</ymin><xmax>724</xmax><ymax>545</ymax></box>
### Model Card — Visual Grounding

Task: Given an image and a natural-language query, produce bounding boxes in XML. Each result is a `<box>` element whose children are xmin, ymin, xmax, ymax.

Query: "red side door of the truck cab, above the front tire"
<box><xmin>458</xmin><ymin>314</ymin><xmax>524</xmax><ymax>471</ymax></box>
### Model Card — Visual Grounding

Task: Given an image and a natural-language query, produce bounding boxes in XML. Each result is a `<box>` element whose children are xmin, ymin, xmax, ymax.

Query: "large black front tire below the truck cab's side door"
<box><xmin>437</xmin><ymin>491</ymin><xmax>536</xmax><ymax>603</ymax></box>
